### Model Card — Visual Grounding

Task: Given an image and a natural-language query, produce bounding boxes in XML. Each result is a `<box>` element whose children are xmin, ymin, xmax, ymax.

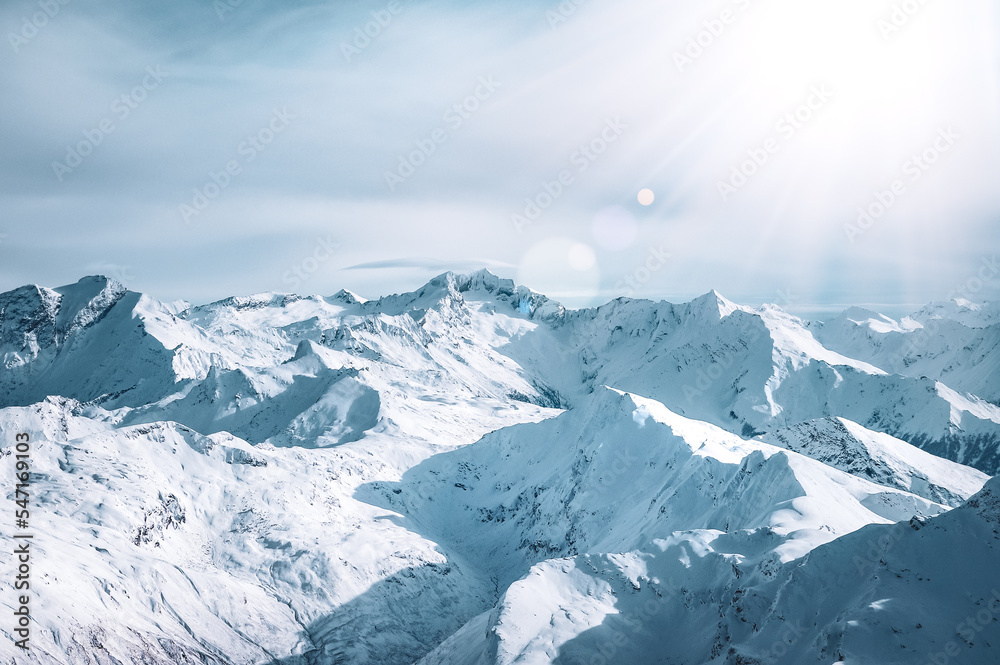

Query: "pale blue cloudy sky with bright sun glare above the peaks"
<box><xmin>0</xmin><ymin>0</ymin><xmax>1000</xmax><ymax>313</ymax></box>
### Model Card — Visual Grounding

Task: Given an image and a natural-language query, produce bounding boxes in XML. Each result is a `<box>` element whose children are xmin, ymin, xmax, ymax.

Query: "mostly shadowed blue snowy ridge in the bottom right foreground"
<box><xmin>421</xmin><ymin>480</ymin><xmax>1000</xmax><ymax>665</ymax></box>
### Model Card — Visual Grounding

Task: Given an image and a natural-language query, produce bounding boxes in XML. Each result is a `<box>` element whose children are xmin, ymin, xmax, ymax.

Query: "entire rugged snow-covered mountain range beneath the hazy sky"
<box><xmin>0</xmin><ymin>271</ymin><xmax>1000</xmax><ymax>665</ymax></box>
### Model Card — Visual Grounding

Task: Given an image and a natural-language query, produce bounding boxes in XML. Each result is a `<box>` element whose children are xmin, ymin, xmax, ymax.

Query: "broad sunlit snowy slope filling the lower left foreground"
<box><xmin>0</xmin><ymin>400</ymin><xmax>556</xmax><ymax>665</ymax></box>
